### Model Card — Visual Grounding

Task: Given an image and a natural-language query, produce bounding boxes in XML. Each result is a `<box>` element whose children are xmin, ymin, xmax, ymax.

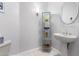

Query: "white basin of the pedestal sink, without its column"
<box><xmin>54</xmin><ymin>33</ymin><xmax>77</xmax><ymax>42</ymax></box>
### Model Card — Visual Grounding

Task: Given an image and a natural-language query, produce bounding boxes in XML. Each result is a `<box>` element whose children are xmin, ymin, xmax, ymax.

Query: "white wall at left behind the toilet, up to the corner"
<box><xmin>0</xmin><ymin>2</ymin><xmax>20</xmax><ymax>54</ymax></box>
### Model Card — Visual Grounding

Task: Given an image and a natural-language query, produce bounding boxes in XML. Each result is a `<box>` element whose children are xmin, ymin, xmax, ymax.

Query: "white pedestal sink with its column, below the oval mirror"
<box><xmin>53</xmin><ymin>32</ymin><xmax>77</xmax><ymax>56</ymax></box>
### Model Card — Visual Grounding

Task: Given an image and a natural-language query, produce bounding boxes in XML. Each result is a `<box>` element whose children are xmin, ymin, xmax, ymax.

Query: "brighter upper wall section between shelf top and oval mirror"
<box><xmin>48</xmin><ymin>2</ymin><xmax>63</xmax><ymax>14</ymax></box>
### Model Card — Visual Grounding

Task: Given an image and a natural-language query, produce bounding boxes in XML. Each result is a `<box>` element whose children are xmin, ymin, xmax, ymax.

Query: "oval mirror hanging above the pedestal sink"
<box><xmin>61</xmin><ymin>2</ymin><xmax>78</xmax><ymax>24</ymax></box>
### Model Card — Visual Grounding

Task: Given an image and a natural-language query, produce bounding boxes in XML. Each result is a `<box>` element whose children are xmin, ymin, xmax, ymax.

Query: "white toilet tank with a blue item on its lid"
<box><xmin>0</xmin><ymin>40</ymin><xmax>11</xmax><ymax>56</ymax></box>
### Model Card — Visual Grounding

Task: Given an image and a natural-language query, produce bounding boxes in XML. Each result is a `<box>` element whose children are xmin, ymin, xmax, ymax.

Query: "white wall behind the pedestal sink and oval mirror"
<box><xmin>48</xmin><ymin>2</ymin><xmax>79</xmax><ymax>56</ymax></box>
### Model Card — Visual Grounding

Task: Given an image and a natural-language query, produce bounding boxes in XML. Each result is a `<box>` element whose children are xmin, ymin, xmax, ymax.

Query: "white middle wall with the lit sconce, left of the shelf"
<box><xmin>20</xmin><ymin>2</ymin><xmax>47</xmax><ymax>51</ymax></box>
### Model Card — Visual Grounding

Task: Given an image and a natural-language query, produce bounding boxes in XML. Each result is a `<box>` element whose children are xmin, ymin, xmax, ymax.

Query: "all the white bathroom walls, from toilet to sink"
<box><xmin>0</xmin><ymin>2</ymin><xmax>79</xmax><ymax>55</ymax></box>
